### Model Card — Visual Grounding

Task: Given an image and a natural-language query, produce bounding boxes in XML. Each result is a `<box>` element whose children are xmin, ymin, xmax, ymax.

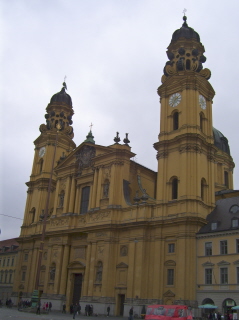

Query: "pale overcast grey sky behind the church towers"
<box><xmin>0</xmin><ymin>0</ymin><xmax>239</xmax><ymax>240</ymax></box>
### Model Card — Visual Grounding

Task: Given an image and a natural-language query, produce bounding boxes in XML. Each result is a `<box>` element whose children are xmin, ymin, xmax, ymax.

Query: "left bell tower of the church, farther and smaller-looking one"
<box><xmin>22</xmin><ymin>82</ymin><xmax>76</xmax><ymax>228</ymax></box>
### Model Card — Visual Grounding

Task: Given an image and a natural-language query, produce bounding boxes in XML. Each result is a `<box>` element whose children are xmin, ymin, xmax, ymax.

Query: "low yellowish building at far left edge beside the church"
<box><xmin>0</xmin><ymin>239</ymin><xmax>19</xmax><ymax>304</ymax></box>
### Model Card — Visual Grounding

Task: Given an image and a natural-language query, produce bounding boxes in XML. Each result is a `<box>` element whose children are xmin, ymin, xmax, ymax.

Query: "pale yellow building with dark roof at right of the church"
<box><xmin>197</xmin><ymin>191</ymin><xmax>239</xmax><ymax>314</ymax></box>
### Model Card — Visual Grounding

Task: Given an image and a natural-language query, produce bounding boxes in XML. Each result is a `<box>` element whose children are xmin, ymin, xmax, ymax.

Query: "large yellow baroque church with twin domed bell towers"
<box><xmin>12</xmin><ymin>17</ymin><xmax>237</xmax><ymax>315</ymax></box>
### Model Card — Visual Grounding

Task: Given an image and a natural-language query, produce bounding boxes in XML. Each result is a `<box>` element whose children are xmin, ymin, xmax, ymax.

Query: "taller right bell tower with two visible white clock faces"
<box><xmin>154</xmin><ymin>16</ymin><xmax>216</xmax><ymax>218</ymax></box>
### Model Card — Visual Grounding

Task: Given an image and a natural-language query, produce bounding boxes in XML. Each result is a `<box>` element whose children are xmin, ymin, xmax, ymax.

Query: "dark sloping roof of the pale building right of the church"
<box><xmin>198</xmin><ymin>197</ymin><xmax>239</xmax><ymax>234</ymax></box>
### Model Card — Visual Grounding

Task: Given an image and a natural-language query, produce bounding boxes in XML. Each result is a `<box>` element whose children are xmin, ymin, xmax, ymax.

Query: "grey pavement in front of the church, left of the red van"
<box><xmin>0</xmin><ymin>307</ymin><xmax>127</xmax><ymax>320</ymax></box>
